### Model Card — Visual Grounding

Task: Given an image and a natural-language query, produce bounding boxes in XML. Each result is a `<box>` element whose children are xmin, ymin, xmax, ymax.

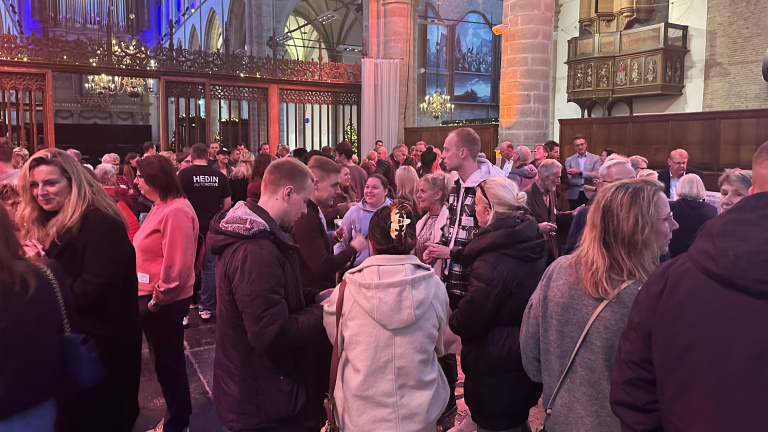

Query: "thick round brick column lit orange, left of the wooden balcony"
<box><xmin>499</xmin><ymin>0</ymin><xmax>554</xmax><ymax>146</ymax></box>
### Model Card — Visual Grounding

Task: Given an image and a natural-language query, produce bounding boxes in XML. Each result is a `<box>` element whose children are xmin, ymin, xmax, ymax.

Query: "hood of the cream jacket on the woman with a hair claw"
<box><xmin>344</xmin><ymin>255</ymin><xmax>445</xmax><ymax>330</ymax></box>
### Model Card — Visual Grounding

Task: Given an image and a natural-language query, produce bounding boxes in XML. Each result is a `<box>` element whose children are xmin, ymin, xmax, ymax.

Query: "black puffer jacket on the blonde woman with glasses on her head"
<box><xmin>450</xmin><ymin>216</ymin><xmax>547</xmax><ymax>430</ymax></box>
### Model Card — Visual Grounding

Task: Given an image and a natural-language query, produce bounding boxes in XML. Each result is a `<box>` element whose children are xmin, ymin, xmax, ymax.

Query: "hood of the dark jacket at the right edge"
<box><xmin>688</xmin><ymin>192</ymin><xmax>768</xmax><ymax>297</ymax></box>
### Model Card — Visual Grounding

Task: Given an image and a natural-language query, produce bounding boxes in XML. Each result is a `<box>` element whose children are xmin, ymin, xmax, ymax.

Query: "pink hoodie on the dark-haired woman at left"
<box><xmin>133</xmin><ymin>198</ymin><xmax>199</xmax><ymax>305</ymax></box>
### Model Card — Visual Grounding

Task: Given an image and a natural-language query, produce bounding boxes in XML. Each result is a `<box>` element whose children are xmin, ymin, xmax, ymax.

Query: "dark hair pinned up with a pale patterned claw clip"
<box><xmin>368</xmin><ymin>200</ymin><xmax>418</xmax><ymax>255</ymax></box>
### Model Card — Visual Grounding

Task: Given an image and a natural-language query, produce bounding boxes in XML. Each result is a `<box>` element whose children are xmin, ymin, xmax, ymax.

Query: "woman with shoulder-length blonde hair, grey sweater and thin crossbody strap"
<box><xmin>520</xmin><ymin>179</ymin><xmax>677</xmax><ymax>432</ymax></box>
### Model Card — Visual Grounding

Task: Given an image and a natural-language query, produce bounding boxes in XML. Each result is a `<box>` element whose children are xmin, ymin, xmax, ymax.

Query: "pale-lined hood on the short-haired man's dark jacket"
<box><xmin>207</xmin><ymin>198</ymin><xmax>295</xmax><ymax>255</ymax></box>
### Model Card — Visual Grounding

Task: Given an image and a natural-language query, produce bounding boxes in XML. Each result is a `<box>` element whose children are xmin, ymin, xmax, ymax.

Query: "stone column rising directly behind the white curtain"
<box><xmin>365</xmin><ymin>0</ymin><xmax>419</xmax><ymax>148</ymax></box>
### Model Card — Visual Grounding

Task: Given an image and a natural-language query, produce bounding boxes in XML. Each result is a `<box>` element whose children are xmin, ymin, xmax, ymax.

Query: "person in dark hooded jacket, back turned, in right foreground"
<box><xmin>610</xmin><ymin>142</ymin><xmax>768</xmax><ymax>432</ymax></box>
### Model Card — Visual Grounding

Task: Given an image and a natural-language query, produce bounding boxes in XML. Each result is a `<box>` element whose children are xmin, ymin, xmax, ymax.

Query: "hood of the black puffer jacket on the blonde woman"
<box><xmin>462</xmin><ymin>216</ymin><xmax>547</xmax><ymax>262</ymax></box>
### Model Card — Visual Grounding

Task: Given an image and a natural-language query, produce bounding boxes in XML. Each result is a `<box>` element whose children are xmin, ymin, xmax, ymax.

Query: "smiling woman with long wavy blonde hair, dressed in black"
<box><xmin>17</xmin><ymin>149</ymin><xmax>141</xmax><ymax>432</ymax></box>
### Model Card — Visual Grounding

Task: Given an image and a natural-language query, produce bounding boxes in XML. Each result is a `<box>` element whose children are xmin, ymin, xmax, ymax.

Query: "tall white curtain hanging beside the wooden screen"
<box><xmin>359</xmin><ymin>59</ymin><xmax>400</xmax><ymax>159</ymax></box>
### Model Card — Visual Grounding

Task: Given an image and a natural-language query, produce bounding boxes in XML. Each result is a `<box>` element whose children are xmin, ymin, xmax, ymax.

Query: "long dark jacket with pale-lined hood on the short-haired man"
<box><xmin>207</xmin><ymin>199</ymin><xmax>331</xmax><ymax>432</ymax></box>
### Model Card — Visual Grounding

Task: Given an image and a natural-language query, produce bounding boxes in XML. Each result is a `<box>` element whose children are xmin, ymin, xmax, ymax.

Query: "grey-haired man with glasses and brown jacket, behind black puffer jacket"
<box><xmin>523</xmin><ymin>159</ymin><xmax>572</xmax><ymax>265</ymax></box>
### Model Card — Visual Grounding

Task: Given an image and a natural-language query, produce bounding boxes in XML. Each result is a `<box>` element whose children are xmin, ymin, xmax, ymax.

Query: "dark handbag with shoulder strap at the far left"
<box><xmin>39</xmin><ymin>265</ymin><xmax>104</xmax><ymax>388</ymax></box>
